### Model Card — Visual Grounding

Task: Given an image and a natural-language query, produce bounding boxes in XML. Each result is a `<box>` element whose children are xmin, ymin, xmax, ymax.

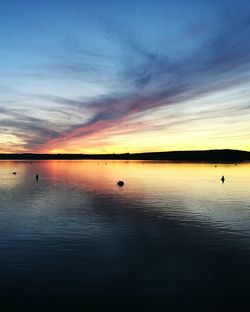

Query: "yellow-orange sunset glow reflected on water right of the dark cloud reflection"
<box><xmin>40</xmin><ymin>161</ymin><xmax>250</xmax><ymax>231</ymax></box>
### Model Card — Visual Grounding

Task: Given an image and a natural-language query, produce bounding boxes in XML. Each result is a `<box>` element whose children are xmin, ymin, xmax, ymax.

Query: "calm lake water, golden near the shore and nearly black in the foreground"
<box><xmin>0</xmin><ymin>161</ymin><xmax>250</xmax><ymax>312</ymax></box>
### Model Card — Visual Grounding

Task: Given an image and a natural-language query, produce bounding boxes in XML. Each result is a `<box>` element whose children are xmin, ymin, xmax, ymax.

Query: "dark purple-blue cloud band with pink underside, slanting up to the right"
<box><xmin>40</xmin><ymin>3</ymin><xmax>250</xmax><ymax>150</ymax></box>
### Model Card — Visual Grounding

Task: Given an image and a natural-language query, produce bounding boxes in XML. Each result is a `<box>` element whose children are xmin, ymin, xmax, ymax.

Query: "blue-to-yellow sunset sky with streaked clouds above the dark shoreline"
<box><xmin>0</xmin><ymin>0</ymin><xmax>250</xmax><ymax>153</ymax></box>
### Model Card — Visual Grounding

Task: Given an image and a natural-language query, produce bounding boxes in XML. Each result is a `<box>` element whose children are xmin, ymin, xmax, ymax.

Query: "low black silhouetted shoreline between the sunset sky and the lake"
<box><xmin>0</xmin><ymin>149</ymin><xmax>250</xmax><ymax>163</ymax></box>
